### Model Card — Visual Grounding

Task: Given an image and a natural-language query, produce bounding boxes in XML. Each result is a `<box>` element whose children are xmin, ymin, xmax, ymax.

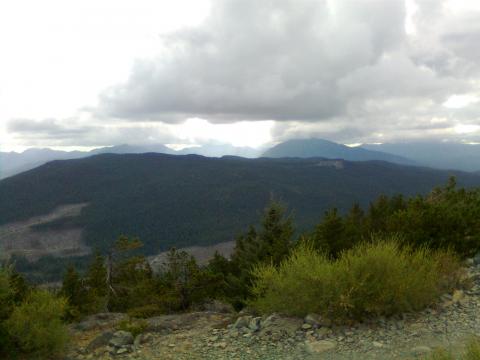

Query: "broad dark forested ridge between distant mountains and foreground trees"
<box><xmin>0</xmin><ymin>153</ymin><xmax>480</xmax><ymax>254</ymax></box>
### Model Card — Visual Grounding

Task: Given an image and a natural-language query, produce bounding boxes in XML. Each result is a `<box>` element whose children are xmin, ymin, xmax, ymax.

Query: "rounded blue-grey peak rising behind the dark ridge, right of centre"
<box><xmin>262</xmin><ymin>139</ymin><xmax>415</xmax><ymax>165</ymax></box>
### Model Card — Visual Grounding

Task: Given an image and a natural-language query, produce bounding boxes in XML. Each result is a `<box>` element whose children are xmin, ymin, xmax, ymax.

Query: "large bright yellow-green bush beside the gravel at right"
<box><xmin>251</xmin><ymin>238</ymin><xmax>460</xmax><ymax>322</ymax></box>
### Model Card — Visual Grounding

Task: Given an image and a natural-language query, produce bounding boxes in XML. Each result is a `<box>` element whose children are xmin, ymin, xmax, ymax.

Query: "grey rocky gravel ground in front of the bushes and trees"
<box><xmin>66</xmin><ymin>261</ymin><xmax>480</xmax><ymax>360</ymax></box>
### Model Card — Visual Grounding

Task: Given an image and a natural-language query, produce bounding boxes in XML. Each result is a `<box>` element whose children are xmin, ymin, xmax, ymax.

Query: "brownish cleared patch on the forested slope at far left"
<box><xmin>0</xmin><ymin>203</ymin><xmax>90</xmax><ymax>261</ymax></box>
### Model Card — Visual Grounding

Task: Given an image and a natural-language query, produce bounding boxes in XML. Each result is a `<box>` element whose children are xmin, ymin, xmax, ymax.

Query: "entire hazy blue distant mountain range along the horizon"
<box><xmin>0</xmin><ymin>139</ymin><xmax>480</xmax><ymax>179</ymax></box>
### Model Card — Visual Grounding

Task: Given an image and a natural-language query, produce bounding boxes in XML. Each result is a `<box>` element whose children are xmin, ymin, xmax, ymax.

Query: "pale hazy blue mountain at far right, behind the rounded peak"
<box><xmin>362</xmin><ymin>142</ymin><xmax>480</xmax><ymax>171</ymax></box>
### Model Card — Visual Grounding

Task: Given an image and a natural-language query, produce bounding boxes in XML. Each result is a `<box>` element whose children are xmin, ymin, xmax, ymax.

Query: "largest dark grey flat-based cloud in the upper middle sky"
<box><xmin>98</xmin><ymin>0</ymin><xmax>405</xmax><ymax>122</ymax></box>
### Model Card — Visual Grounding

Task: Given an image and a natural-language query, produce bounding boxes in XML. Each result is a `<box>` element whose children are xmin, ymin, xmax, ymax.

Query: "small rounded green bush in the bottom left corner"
<box><xmin>5</xmin><ymin>290</ymin><xmax>68</xmax><ymax>358</ymax></box>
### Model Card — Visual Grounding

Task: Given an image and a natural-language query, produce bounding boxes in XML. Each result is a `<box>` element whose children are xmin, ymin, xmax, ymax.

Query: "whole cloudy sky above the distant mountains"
<box><xmin>0</xmin><ymin>0</ymin><xmax>480</xmax><ymax>151</ymax></box>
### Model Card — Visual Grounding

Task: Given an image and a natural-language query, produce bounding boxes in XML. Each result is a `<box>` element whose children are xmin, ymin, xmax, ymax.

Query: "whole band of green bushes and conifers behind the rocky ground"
<box><xmin>0</xmin><ymin>179</ymin><xmax>480</xmax><ymax>358</ymax></box>
